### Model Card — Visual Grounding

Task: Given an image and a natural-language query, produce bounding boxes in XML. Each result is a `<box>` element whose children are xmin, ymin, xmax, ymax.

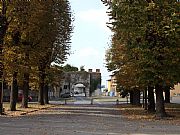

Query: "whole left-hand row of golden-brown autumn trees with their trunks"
<box><xmin>0</xmin><ymin>0</ymin><xmax>73</xmax><ymax>113</ymax></box>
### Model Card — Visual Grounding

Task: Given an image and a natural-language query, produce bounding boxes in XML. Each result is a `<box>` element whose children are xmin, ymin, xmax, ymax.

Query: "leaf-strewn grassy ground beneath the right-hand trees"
<box><xmin>117</xmin><ymin>104</ymin><xmax>180</xmax><ymax>123</ymax></box>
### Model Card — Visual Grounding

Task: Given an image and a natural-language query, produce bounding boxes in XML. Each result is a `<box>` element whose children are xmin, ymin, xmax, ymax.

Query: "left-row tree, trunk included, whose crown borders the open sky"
<box><xmin>26</xmin><ymin>0</ymin><xmax>72</xmax><ymax>104</ymax></box>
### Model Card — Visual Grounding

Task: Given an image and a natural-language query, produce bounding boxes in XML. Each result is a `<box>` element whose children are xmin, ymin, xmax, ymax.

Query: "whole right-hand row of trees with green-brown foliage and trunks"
<box><xmin>102</xmin><ymin>0</ymin><xmax>180</xmax><ymax>117</ymax></box>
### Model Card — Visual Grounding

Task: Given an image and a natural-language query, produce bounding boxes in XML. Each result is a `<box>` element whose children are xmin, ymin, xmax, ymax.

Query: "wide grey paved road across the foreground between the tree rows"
<box><xmin>0</xmin><ymin>104</ymin><xmax>180</xmax><ymax>135</ymax></box>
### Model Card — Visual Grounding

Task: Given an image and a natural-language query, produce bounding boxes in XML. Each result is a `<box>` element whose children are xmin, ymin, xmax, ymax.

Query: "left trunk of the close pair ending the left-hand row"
<box><xmin>38</xmin><ymin>64</ymin><xmax>45</xmax><ymax>105</ymax></box>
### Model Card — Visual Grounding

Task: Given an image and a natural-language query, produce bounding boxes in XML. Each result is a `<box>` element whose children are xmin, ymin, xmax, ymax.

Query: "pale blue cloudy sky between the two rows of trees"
<box><xmin>65</xmin><ymin>0</ymin><xmax>112</xmax><ymax>85</ymax></box>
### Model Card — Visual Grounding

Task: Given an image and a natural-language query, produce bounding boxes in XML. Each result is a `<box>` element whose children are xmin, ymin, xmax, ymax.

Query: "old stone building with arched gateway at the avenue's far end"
<box><xmin>50</xmin><ymin>69</ymin><xmax>101</xmax><ymax>97</ymax></box>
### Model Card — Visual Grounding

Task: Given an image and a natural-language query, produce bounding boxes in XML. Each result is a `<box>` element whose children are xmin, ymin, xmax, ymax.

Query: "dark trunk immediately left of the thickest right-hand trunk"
<box><xmin>148</xmin><ymin>86</ymin><xmax>155</xmax><ymax>113</ymax></box>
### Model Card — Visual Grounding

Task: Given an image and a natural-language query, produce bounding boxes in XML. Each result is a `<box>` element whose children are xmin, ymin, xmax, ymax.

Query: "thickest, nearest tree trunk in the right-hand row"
<box><xmin>156</xmin><ymin>85</ymin><xmax>166</xmax><ymax>118</ymax></box>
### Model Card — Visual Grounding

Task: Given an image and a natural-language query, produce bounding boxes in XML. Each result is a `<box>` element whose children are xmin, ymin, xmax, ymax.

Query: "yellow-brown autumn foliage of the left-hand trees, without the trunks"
<box><xmin>0</xmin><ymin>0</ymin><xmax>72</xmax><ymax>89</ymax></box>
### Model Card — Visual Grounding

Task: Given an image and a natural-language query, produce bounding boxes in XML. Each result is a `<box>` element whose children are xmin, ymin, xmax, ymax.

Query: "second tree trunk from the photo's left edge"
<box><xmin>10</xmin><ymin>72</ymin><xmax>18</xmax><ymax>111</ymax></box>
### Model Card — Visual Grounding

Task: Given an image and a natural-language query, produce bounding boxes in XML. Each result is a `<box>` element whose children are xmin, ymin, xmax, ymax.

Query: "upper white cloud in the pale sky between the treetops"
<box><xmin>77</xmin><ymin>8</ymin><xmax>110</xmax><ymax>31</ymax></box>
